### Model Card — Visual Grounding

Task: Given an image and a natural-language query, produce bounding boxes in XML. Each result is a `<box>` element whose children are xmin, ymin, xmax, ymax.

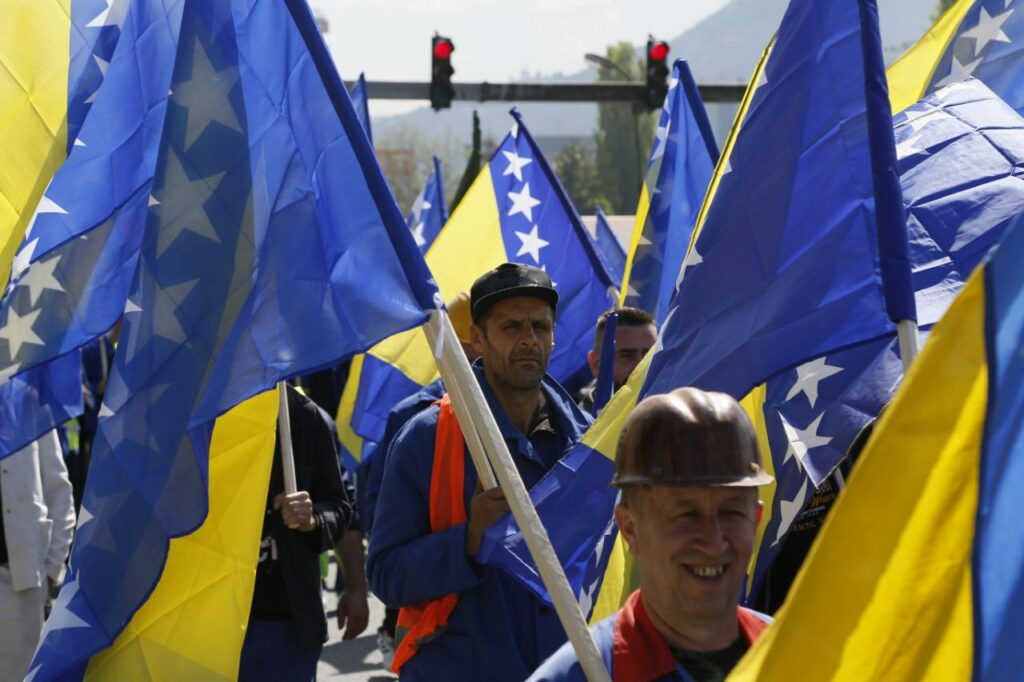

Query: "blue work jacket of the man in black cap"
<box><xmin>367</xmin><ymin>364</ymin><xmax>591</xmax><ymax>682</ymax></box>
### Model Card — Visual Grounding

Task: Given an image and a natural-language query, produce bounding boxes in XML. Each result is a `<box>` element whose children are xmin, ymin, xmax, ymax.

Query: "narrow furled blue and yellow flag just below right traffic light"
<box><xmin>621</xmin><ymin>59</ymin><xmax>719</xmax><ymax>324</ymax></box>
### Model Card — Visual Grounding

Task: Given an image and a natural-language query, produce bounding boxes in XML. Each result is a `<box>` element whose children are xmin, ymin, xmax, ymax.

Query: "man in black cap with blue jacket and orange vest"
<box><xmin>368</xmin><ymin>263</ymin><xmax>590</xmax><ymax>682</ymax></box>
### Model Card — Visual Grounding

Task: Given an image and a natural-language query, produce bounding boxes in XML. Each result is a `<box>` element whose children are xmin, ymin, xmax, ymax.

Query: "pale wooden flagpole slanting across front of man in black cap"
<box><xmin>424</xmin><ymin>309</ymin><xmax>611</xmax><ymax>682</ymax></box>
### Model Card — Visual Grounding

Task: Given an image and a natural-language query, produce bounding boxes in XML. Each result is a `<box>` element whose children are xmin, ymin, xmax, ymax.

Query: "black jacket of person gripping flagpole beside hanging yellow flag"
<box><xmin>270</xmin><ymin>388</ymin><xmax>352</xmax><ymax>644</ymax></box>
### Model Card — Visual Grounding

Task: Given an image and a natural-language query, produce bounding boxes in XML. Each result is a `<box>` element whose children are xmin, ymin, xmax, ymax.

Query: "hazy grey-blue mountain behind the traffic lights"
<box><xmin>368</xmin><ymin>0</ymin><xmax>936</xmax><ymax>146</ymax></box>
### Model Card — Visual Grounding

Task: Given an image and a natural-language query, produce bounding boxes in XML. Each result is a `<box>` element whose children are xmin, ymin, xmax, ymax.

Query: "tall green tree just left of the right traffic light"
<box><xmin>595</xmin><ymin>42</ymin><xmax>654</xmax><ymax>214</ymax></box>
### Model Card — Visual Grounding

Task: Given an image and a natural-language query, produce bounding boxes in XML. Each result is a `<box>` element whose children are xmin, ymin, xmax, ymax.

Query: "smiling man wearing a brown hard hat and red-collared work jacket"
<box><xmin>530</xmin><ymin>388</ymin><xmax>772</xmax><ymax>682</ymax></box>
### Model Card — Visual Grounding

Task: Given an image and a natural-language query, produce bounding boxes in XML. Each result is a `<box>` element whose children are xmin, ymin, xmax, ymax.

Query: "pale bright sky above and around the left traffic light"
<box><xmin>309</xmin><ymin>0</ymin><xmax>728</xmax><ymax>116</ymax></box>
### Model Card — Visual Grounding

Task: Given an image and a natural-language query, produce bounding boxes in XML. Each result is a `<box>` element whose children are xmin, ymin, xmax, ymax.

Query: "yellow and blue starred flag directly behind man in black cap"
<box><xmin>339</xmin><ymin>112</ymin><xmax>611</xmax><ymax>450</ymax></box>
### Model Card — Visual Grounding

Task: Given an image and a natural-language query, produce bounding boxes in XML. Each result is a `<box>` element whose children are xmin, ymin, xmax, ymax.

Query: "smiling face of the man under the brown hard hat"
<box><xmin>615</xmin><ymin>485</ymin><xmax>758</xmax><ymax>623</ymax></box>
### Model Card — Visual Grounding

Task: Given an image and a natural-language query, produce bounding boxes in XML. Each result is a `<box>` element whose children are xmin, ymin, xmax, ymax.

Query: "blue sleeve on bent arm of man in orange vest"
<box><xmin>367</xmin><ymin>408</ymin><xmax>483</xmax><ymax>607</ymax></box>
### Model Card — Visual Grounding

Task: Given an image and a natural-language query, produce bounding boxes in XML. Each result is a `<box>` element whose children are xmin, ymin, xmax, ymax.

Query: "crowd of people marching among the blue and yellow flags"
<box><xmin>0</xmin><ymin>263</ymin><xmax>864</xmax><ymax>682</ymax></box>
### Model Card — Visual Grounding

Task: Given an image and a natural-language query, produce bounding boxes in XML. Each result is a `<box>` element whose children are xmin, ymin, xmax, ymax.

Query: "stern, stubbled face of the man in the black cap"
<box><xmin>472</xmin><ymin>296</ymin><xmax>555</xmax><ymax>391</ymax></box>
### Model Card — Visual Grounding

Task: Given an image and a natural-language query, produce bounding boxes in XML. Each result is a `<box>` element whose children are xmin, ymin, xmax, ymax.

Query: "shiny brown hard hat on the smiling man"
<box><xmin>611</xmin><ymin>388</ymin><xmax>772</xmax><ymax>487</ymax></box>
